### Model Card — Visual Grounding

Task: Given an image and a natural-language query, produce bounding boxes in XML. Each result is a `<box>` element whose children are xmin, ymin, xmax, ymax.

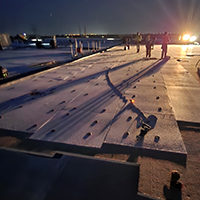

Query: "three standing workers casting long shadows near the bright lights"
<box><xmin>131</xmin><ymin>32</ymin><xmax>169</xmax><ymax>59</ymax></box>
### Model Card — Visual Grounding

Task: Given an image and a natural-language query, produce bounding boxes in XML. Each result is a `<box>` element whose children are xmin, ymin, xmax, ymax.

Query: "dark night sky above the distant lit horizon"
<box><xmin>0</xmin><ymin>0</ymin><xmax>200</xmax><ymax>35</ymax></box>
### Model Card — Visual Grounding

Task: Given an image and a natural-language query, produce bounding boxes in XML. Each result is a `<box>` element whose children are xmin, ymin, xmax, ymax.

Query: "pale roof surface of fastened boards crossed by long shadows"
<box><xmin>0</xmin><ymin>45</ymin><xmax>200</xmax><ymax>158</ymax></box>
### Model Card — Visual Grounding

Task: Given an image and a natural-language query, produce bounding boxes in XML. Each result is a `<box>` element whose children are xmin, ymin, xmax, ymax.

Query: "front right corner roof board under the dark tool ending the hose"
<box><xmin>105</xmin><ymin>110</ymin><xmax>186</xmax><ymax>153</ymax></box>
